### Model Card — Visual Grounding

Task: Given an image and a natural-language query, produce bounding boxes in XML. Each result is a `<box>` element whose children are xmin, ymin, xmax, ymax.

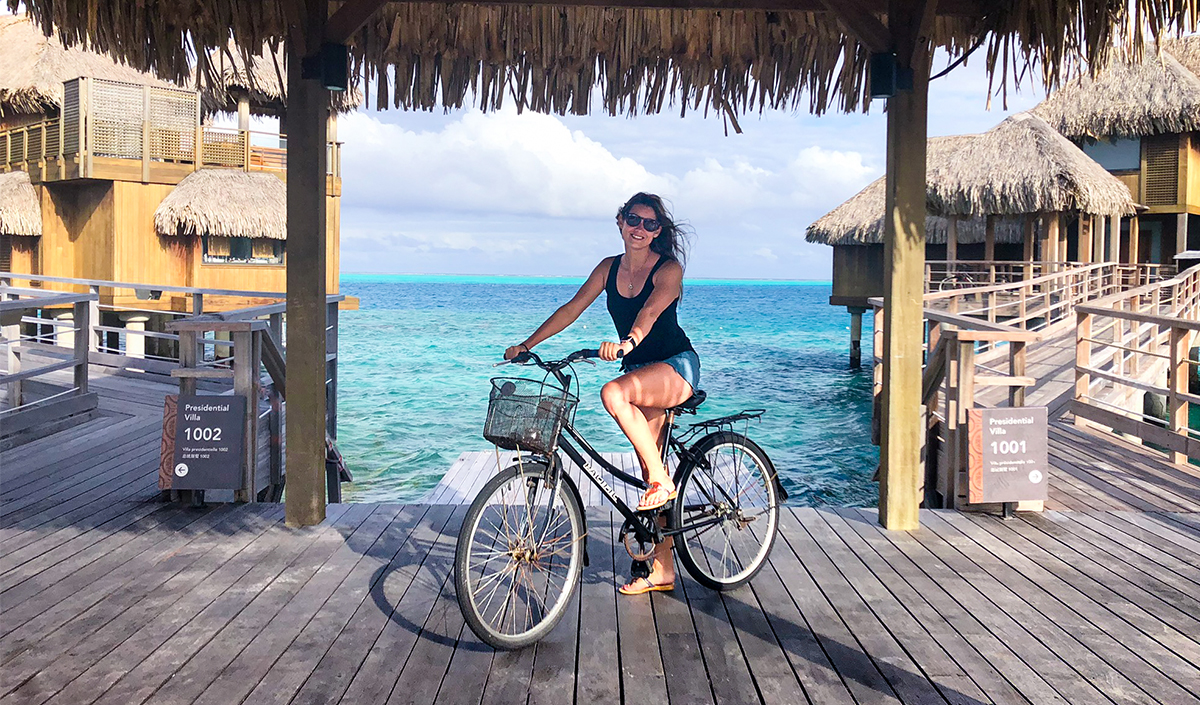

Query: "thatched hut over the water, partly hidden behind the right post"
<box><xmin>805</xmin><ymin>113</ymin><xmax>1136</xmax><ymax>318</ymax></box>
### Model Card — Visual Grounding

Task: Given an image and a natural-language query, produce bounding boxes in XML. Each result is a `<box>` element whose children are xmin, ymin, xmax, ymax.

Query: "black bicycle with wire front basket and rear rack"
<box><xmin>454</xmin><ymin>350</ymin><xmax>787</xmax><ymax>650</ymax></box>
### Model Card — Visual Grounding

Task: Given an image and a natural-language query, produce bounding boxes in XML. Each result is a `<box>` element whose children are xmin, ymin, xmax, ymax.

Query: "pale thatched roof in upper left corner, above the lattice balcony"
<box><xmin>0</xmin><ymin>14</ymin><xmax>176</xmax><ymax>115</ymax></box>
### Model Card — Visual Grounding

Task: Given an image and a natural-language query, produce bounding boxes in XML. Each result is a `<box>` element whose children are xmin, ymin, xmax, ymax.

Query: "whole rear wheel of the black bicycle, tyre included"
<box><xmin>673</xmin><ymin>430</ymin><xmax>780</xmax><ymax>590</ymax></box>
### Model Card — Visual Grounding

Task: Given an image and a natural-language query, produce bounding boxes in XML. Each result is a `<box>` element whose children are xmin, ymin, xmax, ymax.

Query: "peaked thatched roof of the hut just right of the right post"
<box><xmin>926</xmin><ymin>113</ymin><xmax>1134</xmax><ymax>216</ymax></box>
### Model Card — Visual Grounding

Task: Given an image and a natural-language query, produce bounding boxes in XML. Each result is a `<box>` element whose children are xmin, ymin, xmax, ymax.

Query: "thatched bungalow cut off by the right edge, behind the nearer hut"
<box><xmin>1032</xmin><ymin>37</ymin><xmax>1200</xmax><ymax>264</ymax></box>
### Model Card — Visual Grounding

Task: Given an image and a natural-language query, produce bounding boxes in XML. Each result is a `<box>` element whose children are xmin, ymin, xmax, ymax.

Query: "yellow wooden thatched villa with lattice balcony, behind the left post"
<box><xmin>0</xmin><ymin>16</ymin><xmax>356</xmax><ymax>353</ymax></box>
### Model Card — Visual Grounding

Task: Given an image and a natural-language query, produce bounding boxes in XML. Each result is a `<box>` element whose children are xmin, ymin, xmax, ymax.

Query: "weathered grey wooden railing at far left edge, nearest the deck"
<box><xmin>0</xmin><ymin>279</ymin><xmax>96</xmax><ymax>447</ymax></box>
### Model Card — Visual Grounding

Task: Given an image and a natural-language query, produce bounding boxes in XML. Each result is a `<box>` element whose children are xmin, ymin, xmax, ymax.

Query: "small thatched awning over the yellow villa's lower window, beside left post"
<box><xmin>154</xmin><ymin>169</ymin><xmax>287</xmax><ymax>240</ymax></box>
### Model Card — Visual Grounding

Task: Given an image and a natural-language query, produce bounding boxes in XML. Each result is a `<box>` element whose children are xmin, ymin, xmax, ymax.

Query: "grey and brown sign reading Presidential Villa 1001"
<box><xmin>967</xmin><ymin>406</ymin><xmax>1049</xmax><ymax>504</ymax></box>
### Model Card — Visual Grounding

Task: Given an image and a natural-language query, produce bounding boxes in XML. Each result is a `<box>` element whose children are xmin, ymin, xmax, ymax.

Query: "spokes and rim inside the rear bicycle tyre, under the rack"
<box><xmin>677</xmin><ymin>444</ymin><xmax>776</xmax><ymax>584</ymax></box>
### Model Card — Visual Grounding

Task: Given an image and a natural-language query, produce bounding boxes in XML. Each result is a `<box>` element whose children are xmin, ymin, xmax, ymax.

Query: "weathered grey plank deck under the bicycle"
<box><xmin>0</xmin><ymin>369</ymin><xmax>1200</xmax><ymax>705</ymax></box>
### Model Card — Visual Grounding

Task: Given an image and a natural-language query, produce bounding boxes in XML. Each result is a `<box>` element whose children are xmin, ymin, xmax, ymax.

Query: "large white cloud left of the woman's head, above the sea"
<box><xmin>340</xmin><ymin>110</ymin><xmax>666</xmax><ymax>218</ymax></box>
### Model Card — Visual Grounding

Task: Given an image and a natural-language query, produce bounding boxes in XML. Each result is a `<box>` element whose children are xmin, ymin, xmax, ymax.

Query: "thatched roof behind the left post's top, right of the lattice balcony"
<box><xmin>187</xmin><ymin>44</ymin><xmax>362</xmax><ymax>116</ymax></box>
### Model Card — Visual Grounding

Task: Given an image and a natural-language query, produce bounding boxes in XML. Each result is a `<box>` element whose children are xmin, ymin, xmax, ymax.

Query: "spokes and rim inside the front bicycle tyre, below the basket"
<box><xmin>466</xmin><ymin>472</ymin><xmax>581</xmax><ymax>638</ymax></box>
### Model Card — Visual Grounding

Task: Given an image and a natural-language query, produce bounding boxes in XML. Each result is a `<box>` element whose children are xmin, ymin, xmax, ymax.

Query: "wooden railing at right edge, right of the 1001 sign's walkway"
<box><xmin>1070</xmin><ymin>266</ymin><xmax>1200</xmax><ymax>463</ymax></box>
